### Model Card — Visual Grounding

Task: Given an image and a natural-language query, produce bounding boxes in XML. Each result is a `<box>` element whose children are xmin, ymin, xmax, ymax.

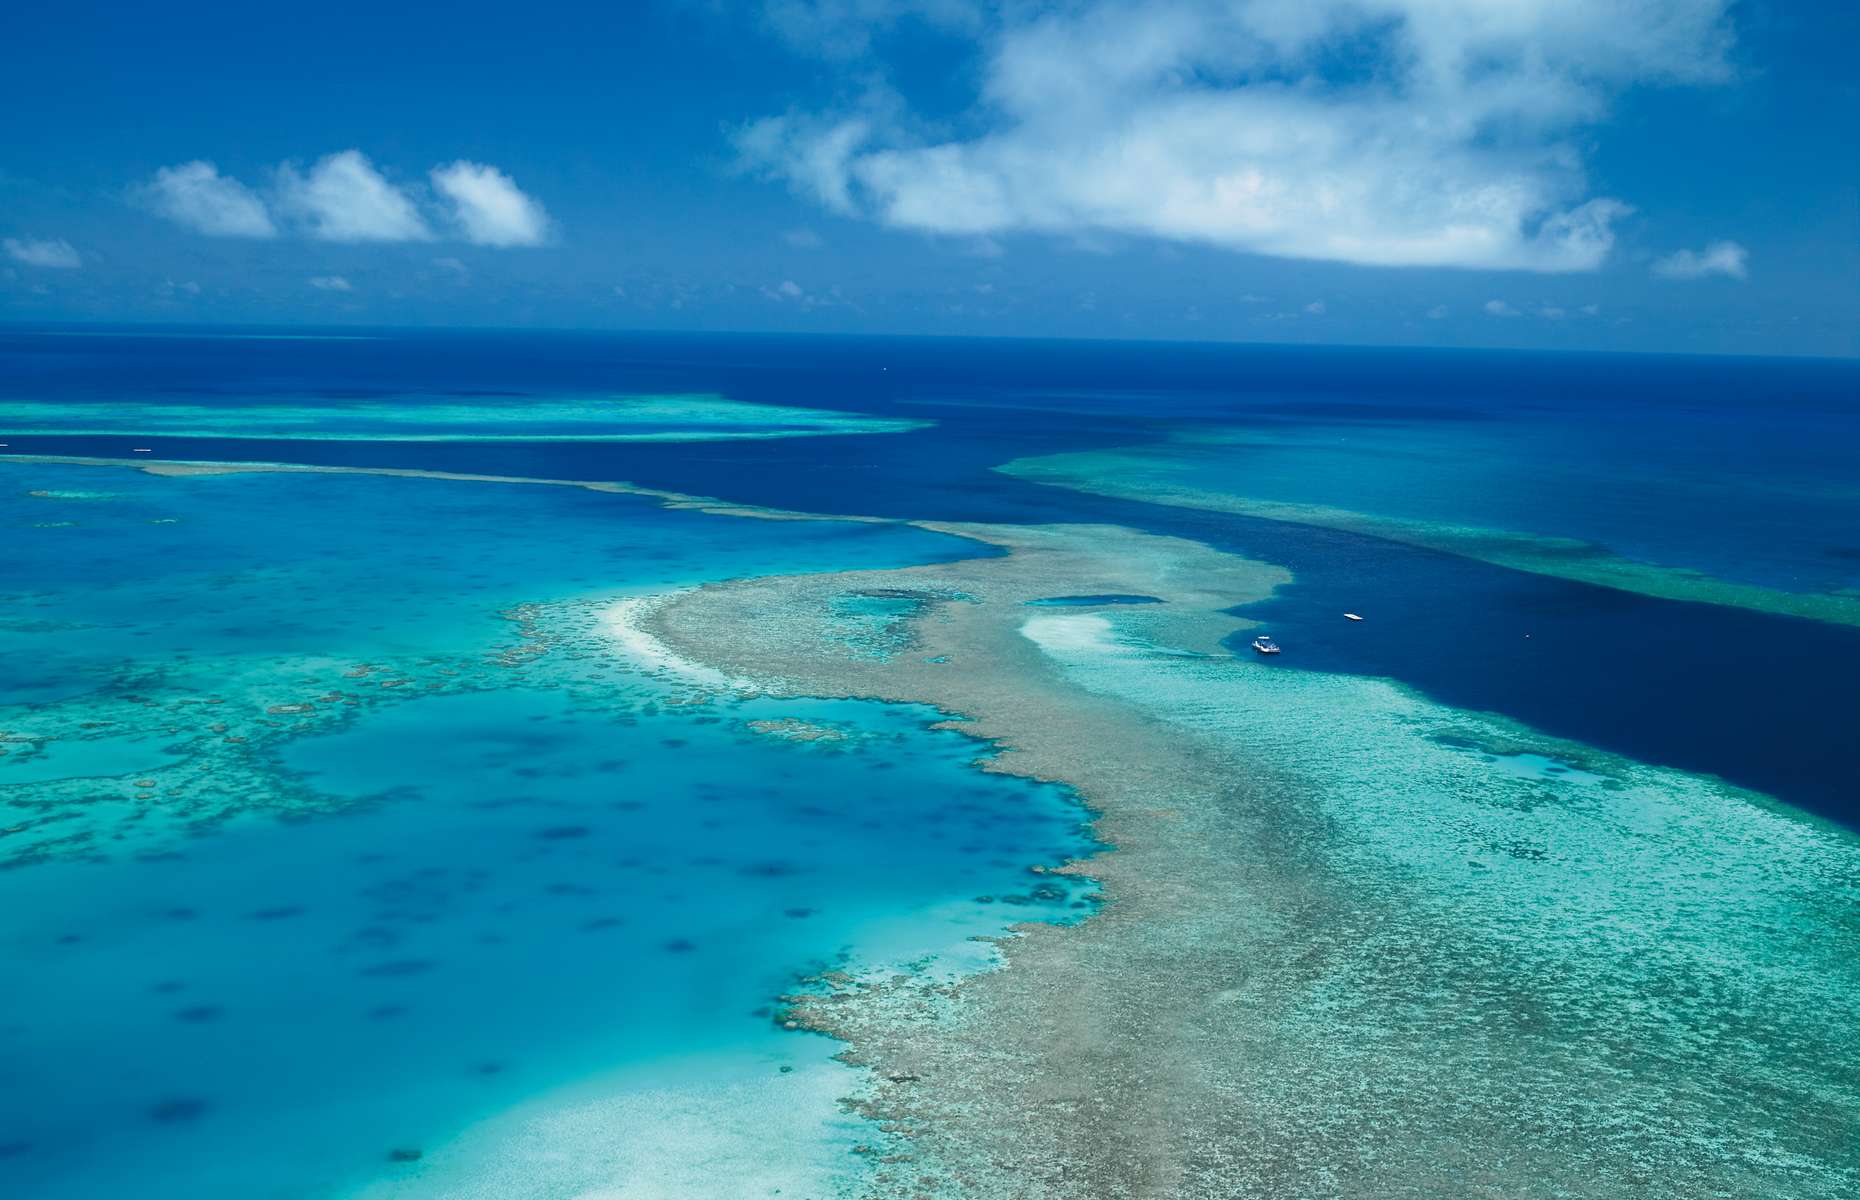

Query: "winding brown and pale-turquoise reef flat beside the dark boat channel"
<box><xmin>645</xmin><ymin>527</ymin><xmax>1860</xmax><ymax>1198</ymax></box>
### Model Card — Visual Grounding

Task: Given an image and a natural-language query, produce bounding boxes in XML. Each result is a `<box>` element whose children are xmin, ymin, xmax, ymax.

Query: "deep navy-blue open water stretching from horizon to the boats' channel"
<box><xmin>0</xmin><ymin>331</ymin><xmax>1860</xmax><ymax>824</ymax></box>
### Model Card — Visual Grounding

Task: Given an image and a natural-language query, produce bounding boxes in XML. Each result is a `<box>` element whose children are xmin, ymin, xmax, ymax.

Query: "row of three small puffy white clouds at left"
<box><xmin>136</xmin><ymin>149</ymin><xmax>551</xmax><ymax>247</ymax></box>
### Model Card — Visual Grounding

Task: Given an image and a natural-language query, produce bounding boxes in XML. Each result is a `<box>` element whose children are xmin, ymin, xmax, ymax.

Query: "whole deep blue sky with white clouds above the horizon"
<box><xmin>0</xmin><ymin>0</ymin><xmax>1860</xmax><ymax>357</ymax></box>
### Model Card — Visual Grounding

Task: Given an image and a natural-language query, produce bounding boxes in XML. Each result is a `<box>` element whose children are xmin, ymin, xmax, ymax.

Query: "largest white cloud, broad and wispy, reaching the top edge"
<box><xmin>738</xmin><ymin>0</ymin><xmax>1730</xmax><ymax>272</ymax></box>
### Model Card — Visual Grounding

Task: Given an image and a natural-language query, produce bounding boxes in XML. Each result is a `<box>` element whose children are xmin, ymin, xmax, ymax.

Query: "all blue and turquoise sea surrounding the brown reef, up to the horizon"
<box><xmin>0</xmin><ymin>329</ymin><xmax>1860</xmax><ymax>1200</ymax></box>
